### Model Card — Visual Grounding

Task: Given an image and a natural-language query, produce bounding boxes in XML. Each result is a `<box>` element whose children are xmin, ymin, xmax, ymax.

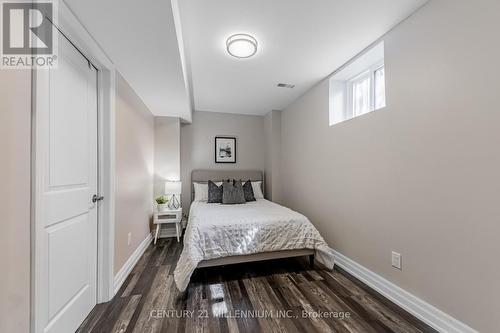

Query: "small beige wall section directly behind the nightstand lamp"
<box><xmin>154</xmin><ymin>117</ymin><xmax>181</xmax><ymax>197</ymax></box>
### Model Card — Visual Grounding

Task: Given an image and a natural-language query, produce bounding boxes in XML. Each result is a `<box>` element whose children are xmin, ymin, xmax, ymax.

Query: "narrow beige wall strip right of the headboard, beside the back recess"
<box><xmin>264</xmin><ymin>110</ymin><xmax>281</xmax><ymax>202</ymax></box>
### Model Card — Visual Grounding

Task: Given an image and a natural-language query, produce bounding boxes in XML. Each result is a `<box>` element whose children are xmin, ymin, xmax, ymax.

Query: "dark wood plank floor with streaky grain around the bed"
<box><xmin>77</xmin><ymin>238</ymin><xmax>435</xmax><ymax>333</ymax></box>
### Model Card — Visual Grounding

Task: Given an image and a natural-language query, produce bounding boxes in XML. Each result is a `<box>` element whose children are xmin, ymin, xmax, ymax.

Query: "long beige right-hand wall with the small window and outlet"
<box><xmin>281</xmin><ymin>0</ymin><xmax>500</xmax><ymax>332</ymax></box>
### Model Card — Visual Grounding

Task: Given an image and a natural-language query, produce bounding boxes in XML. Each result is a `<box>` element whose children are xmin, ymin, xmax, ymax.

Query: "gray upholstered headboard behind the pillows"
<box><xmin>191</xmin><ymin>170</ymin><xmax>264</xmax><ymax>202</ymax></box>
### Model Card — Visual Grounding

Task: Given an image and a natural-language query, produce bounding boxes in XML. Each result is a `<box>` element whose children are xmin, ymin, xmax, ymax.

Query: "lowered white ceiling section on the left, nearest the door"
<box><xmin>64</xmin><ymin>0</ymin><xmax>192</xmax><ymax>121</ymax></box>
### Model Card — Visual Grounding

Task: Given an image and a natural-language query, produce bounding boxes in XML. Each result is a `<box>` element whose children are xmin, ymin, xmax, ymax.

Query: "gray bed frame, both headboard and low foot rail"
<box><xmin>191</xmin><ymin>170</ymin><xmax>314</xmax><ymax>268</ymax></box>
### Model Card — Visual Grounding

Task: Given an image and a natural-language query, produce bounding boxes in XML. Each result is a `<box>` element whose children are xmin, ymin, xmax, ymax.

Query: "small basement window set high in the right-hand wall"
<box><xmin>329</xmin><ymin>42</ymin><xmax>386</xmax><ymax>126</ymax></box>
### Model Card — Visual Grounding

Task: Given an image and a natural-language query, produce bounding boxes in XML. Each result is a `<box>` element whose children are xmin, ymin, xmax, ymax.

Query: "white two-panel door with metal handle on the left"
<box><xmin>34</xmin><ymin>30</ymin><xmax>97</xmax><ymax>333</ymax></box>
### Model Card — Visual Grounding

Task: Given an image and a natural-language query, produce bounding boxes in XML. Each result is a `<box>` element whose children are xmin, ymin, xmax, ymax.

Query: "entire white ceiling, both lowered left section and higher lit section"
<box><xmin>64</xmin><ymin>0</ymin><xmax>427</xmax><ymax>121</ymax></box>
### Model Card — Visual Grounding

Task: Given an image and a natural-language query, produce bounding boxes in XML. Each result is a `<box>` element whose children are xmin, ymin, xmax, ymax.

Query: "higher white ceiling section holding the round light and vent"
<box><xmin>180</xmin><ymin>0</ymin><xmax>427</xmax><ymax>115</ymax></box>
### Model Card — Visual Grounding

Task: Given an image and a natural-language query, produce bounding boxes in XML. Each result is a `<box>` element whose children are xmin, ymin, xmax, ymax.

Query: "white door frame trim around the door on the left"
<box><xmin>30</xmin><ymin>0</ymin><xmax>116</xmax><ymax>333</ymax></box>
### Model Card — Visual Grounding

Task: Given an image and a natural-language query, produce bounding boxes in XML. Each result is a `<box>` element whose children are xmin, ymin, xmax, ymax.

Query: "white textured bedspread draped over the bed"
<box><xmin>174</xmin><ymin>199</ymin><xmax>333</xmax><ymax>291</ymax></box>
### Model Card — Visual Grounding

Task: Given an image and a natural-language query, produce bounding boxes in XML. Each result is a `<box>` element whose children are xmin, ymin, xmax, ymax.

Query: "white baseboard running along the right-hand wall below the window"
<box><xmin>332</xmin><ymin>250</ymin><xmax>478</xmax><ymax>333</ymax></box>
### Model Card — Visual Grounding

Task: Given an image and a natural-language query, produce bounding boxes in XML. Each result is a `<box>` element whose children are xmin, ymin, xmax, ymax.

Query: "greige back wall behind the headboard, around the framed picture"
<box><xmin>181</xmin><ymin>112</ymin><xmax>265</xmax><ymax>209</ymax></box>
